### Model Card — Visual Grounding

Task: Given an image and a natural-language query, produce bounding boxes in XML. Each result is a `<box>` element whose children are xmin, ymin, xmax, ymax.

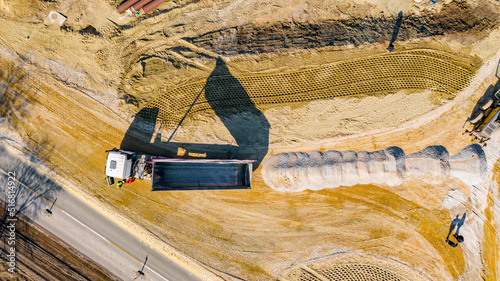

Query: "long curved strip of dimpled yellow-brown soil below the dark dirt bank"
<box><xmin>146</xmin><ymin>50</ymin><xmax>473</xmax><ymax>128</ymax></box>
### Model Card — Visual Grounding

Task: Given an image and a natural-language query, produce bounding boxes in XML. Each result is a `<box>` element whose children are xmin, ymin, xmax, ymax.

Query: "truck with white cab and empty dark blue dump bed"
<box><xmin>106</xmin><ymin>149</ymin><xmax>255</xmax><ymax>191</ymax></box>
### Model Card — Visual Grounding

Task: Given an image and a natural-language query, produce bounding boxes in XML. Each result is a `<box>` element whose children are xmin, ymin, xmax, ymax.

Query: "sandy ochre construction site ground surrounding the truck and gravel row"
<box><xmin>0</xmin><ymin>0</ymin><xmax>500</xmax><ymax>280</ymax></box>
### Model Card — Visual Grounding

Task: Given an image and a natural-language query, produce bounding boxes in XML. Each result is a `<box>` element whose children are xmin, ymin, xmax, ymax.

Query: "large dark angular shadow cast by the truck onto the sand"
<box><xmin>120</xmin><ymin>58</ymin><xmax>270</xmax><ymax>170</ymax></box>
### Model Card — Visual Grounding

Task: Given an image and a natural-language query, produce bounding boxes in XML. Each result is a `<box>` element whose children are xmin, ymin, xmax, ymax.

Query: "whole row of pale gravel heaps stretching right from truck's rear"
<box><xmin>262</xmin><ymin>144</ymin><xmax>486</xmax><ymax>192</ymax></box>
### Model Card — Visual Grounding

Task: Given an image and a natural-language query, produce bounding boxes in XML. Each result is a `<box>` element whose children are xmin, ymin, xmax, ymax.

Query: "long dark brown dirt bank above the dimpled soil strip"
<box><xmin>185</xmin><ymin>1</ymin><xmax>498</xmax><ymax>55</ymax></box>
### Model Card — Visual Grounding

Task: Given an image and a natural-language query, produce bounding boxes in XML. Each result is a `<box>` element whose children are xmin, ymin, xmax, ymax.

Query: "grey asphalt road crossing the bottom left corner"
<box><xmin>0</xmin><ymin>146</ymin><xmax>200</xmax><ymax>281</ymax></box>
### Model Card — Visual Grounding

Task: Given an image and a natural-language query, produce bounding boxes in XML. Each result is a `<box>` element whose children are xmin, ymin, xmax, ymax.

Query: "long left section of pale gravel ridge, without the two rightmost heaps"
<box><xmin>262</xmin><ymin>147</ymin><xmax>406</xmax><ymax>192</ymax></box>
